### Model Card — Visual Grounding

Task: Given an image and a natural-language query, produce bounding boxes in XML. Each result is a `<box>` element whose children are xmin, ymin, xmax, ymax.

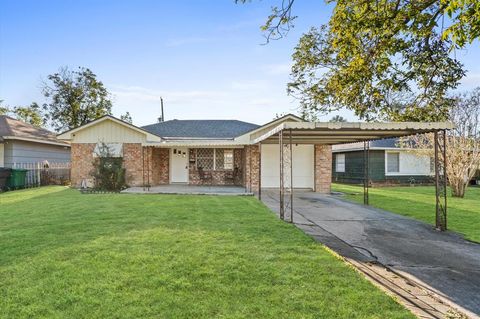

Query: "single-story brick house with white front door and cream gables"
<box><xmin>58</xmin><ymin>114</ymin><xmax>332</xmax><ymax>192</ymax></box>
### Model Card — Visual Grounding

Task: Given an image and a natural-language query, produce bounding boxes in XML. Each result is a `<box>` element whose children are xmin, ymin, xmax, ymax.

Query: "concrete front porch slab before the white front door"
<box><xmin>122</xmin><ymin>184</ymin><xmax>253</xmax><ymax>196</ymax></box>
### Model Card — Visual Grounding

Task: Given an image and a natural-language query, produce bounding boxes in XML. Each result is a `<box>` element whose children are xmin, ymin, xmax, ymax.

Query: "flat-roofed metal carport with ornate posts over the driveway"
<box><xmin>252</xmin><ymin>122</ymin><xmax>454</xmax><ymax>230</ymax></box>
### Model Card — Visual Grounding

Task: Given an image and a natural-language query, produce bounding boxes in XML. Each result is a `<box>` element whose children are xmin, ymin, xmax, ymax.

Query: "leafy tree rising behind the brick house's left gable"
<box><xmin>42</xmin><ymin>67</ymin><xmax>112</xmax><ymax>131</ymax></box>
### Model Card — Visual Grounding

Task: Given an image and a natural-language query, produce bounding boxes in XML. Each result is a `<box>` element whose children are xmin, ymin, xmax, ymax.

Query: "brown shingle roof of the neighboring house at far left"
<box><xmin>0</xmin><ymin>115</ymin><xmax>69</xmax><ymax>146</ymax></box>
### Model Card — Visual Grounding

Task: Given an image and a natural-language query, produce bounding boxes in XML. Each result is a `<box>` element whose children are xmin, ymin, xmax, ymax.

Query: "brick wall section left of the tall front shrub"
<box><xmin>70</xmin><ymin>143</ymin><xmax>96</xmax><ymax>187</ymax></box>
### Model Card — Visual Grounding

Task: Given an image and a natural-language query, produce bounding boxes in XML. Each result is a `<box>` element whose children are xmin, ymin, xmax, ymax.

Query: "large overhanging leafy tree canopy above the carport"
<box><xmin>237</xmin><ymin>0</ymin><xmax>480</xmax><ymax>121</ymax></box>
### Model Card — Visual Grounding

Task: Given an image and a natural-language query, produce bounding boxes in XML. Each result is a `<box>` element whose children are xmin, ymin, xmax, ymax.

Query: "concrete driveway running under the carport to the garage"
<box><xmin>262</xmin><ymin>190</ymin><xmax>480</xmax><ymax>314</ymax></box>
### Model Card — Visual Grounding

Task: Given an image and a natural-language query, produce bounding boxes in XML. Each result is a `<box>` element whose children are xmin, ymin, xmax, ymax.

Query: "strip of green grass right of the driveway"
<box><xmin>332</xmin><ymin>184</ymin><xmax>480</xmax><ymax>242</ymax></box>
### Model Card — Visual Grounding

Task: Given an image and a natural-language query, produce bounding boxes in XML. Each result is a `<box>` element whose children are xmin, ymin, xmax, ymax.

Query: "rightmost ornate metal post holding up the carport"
<box><xmin>434</xmin><ymin>130</ymin><xmax>448</xmax><ymax>231</ymax></box>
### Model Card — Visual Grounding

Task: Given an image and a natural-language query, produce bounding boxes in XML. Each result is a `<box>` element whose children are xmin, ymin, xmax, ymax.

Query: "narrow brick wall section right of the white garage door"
<box><xmin>315</xmin><ymin>145</ymin><xmax>332</xmax><ymax>194</ymax></box>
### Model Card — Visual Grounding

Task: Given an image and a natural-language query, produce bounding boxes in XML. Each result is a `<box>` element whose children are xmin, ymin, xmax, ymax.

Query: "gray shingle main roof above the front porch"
<box><xmin>142</xmin><ymin>120</ymin><xmax>259</xmax><ymax>139</ymax></box>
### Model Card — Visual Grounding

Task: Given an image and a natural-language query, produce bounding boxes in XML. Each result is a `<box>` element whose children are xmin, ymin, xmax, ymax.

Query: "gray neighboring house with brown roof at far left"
<box><xmin>0</xmin><ymin>115</ymin><xmax>70</xmax><ymax>167</ymax></box>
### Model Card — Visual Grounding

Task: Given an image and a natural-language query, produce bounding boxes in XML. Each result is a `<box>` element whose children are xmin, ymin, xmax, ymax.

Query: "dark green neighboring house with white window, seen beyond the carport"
<box><xmin>332</xmin><ymin>138</ymin><xmax>434</xmax><ymax>184</ymax></box>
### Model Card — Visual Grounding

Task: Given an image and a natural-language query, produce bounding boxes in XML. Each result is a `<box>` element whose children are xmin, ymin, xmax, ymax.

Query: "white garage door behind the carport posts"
<box><xmin>262</xmin><ymin>144</ymin><xmax>314</xmax><ymax>189</ymax></box>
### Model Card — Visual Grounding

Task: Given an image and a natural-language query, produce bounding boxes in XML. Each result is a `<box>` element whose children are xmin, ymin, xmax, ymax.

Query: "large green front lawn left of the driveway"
<box><xmin>0</xmin><ymin>187</ymin><xmax>413</xmax><ymax>318</ymax></box>
